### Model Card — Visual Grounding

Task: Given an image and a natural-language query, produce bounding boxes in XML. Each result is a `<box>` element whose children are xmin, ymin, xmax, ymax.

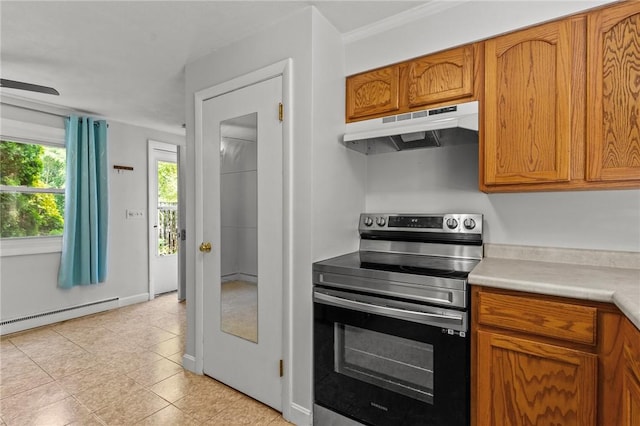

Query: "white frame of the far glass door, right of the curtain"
<box><xmin>147</xmin><ymin>139</ymin><xmax>182</xmax><ymax>300</ymax></box>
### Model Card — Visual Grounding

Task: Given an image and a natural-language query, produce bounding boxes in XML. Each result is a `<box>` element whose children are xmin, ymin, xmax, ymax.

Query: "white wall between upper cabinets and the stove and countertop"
<box><xmin>367</xmin><ymin>145</ymin><xmax>640</xmax><ymax>252</ymax></box>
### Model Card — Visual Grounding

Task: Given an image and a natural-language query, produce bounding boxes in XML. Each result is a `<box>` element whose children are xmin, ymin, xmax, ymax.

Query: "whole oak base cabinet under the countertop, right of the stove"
<box><xmin>471</xmin><ymin>286</ymin><xmax>640</xmax><ymax>426</ymax></box>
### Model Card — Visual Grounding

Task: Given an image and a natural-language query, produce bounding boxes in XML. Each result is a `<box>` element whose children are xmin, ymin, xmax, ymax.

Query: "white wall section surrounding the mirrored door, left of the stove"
<box><xmin>186</xmin><ymin>8</ymin><xmax>365</xmax><ymax>424</ymax></box>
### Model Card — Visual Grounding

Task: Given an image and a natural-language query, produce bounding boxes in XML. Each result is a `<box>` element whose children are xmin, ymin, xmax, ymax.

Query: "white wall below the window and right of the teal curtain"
<box><xmin>0</xmin><ymin>116</ymin><xmax>184</xmax><ymax>320</ymax></box>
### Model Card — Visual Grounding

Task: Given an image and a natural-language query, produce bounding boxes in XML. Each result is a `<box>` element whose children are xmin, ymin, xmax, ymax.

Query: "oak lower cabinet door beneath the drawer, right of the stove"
<box><xmin>476</xmin><ymin>330</ymin><xmax>598</xmax><ymax>426</ymax></box>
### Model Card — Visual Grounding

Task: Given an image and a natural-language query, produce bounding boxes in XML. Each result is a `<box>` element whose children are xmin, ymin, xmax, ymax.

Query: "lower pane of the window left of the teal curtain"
<box><xmin>0</xmin><ymin>192</ymin><xmax>64</xmax><ymax>238</ymax></box>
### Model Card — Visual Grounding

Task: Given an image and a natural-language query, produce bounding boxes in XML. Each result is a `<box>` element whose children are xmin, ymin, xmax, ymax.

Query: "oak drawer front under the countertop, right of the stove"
<box><xmin>477</xmin><ymin>292</ymin><xmax>597</xmax><ymax>345</ymax></box>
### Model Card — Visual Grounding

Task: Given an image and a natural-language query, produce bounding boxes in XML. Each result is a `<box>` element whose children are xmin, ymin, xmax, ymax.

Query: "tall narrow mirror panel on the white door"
<box><xmin>220</xmin><ymin>113</ymin><xmax>258</xmax><ymax>343</ymax></box>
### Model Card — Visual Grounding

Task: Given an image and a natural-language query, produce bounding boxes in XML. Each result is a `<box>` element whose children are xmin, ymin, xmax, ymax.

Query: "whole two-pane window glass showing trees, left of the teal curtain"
<box><xmin>0</xmin><ymin>140</ymin><xmax>66</xmax><ymax>239</ymax></box>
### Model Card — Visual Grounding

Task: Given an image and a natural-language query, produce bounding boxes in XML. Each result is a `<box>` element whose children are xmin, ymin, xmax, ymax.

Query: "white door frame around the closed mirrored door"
<box><xmin>189</xmin><ymin>58</ymin><xmax>293</xmax><ymax>412</ymax></box>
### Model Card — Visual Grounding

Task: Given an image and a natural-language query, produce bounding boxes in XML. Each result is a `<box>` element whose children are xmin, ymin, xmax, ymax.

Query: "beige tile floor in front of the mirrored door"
<box><xmin>0</xmin><ymin>294</ymin><xmax>289</xmax><ymax>426</ymax></box>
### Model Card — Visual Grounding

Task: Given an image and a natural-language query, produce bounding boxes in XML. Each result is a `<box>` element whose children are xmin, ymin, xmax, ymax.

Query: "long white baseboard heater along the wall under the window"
<box><xmin>0</xmin><ymin>297</ymin><xmax>120</xmax><ymax>335</ymax></box>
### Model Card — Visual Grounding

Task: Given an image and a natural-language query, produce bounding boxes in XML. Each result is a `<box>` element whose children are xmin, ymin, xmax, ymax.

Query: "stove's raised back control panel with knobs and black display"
<box><xmin>358</xmin><ymin>213</ymin><xmax>482</xmax><ymax>234</ymax></box>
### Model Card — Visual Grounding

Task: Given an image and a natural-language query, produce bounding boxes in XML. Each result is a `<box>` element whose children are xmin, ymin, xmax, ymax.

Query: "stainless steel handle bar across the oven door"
<box><xmin>313</xmin><ymin>290</ymin><xmax>466</xmax><ymax>331</ymax></box>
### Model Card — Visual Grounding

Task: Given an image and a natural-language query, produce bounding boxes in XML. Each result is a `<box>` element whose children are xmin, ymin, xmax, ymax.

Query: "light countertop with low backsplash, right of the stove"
<box><xmin>469</xmin><ymin>244</ymin><xmax>640</xmax><ymax>329</ymax></box>
